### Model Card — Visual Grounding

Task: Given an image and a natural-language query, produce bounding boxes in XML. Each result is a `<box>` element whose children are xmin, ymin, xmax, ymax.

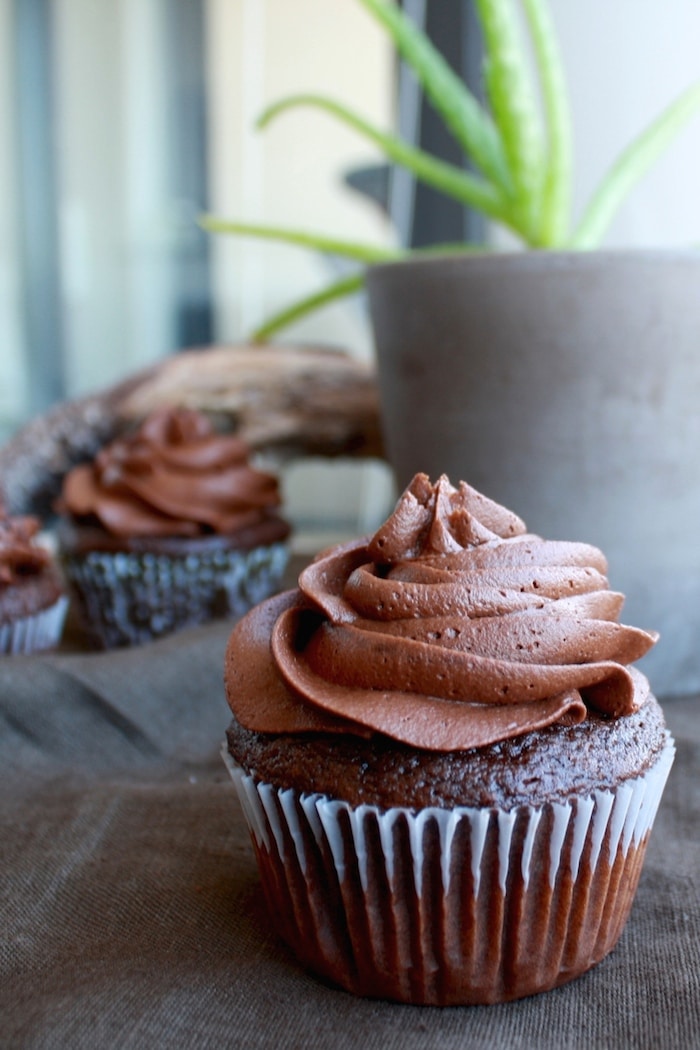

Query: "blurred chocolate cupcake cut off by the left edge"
<box><xmin>0</xmin><ymin>506</ymin><xmax>68</xmax><ymax>654</ymax></box>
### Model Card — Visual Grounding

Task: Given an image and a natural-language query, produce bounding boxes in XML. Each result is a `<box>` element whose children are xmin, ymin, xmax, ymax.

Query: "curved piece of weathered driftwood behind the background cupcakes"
<box><xmin>0</xmin><ymin>345</ymin><xmax>383</xmax><ymax>517</ymax></box>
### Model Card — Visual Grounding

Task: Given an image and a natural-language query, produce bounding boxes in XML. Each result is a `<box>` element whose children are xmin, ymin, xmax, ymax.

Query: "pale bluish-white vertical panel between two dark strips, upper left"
<box><xmin>52</xmin><ymin>0</ymin><xmax>179</xmax><ymax>396</ymax></box>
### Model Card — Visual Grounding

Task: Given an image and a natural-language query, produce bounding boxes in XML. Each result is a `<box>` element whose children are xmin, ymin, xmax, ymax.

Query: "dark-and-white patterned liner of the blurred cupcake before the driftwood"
<box><xmin>63</xmin><ymin>543</ymin><xmax>289</xmax><ymax>649</ymax></box>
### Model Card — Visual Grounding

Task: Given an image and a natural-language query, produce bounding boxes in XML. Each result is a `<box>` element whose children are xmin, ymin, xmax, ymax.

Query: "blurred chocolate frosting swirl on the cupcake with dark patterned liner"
<box><xmin>61</xmin><ymin>408</ymin><xmax>280</xmax><ymax>537</ymax></box>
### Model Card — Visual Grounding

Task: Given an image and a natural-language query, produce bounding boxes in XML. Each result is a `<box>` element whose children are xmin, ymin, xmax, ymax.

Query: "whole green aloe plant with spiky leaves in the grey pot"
<box><xmin>201</xmin><ymin>0</ymin><xmax>700</xmax><ymax>340</ymax></box>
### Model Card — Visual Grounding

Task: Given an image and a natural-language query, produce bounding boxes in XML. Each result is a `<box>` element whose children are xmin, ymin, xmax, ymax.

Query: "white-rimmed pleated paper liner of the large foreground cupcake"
<box><xmin>222</xmin><ymin>737</ymin><xmax>675</xmax><ymax>1005</ymax></box>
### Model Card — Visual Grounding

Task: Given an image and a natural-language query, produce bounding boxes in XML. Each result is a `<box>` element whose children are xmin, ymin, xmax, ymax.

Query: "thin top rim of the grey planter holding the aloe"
<box><xmin>367</xmin><ymin>248</ymin><xmax>700</xmax><ymax>281</ymax></box>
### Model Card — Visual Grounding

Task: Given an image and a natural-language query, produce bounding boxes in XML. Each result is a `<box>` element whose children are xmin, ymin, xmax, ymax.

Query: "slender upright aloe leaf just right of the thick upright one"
<box><xmin>523</xmin><ymin>0</ymin><xmax>573</xmax><ymax>247</ymax></box>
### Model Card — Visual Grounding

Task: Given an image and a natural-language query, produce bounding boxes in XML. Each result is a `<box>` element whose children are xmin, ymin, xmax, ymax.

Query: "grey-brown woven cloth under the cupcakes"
<box><xmin>0</xmin><ymin>609</ymin><xmax>700</xmax><ymax>1050</ymax></box>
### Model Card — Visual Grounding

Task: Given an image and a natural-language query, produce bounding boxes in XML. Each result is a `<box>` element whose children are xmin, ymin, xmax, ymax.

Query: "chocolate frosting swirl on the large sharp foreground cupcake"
<box><xmin>228</xmin><ymin>475</ymin><xmax>657</xmax><ymax>751</ymax></box>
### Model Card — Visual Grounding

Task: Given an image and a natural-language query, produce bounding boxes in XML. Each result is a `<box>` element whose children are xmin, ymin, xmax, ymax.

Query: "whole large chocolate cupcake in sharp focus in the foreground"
<box><xmin>224</xmin><ymin>475</ymin><xmax>674</xmax><ymax>1005</ymax></box>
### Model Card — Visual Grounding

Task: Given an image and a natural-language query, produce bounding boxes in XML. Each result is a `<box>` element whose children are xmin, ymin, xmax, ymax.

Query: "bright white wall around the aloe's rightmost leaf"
<box><xmin>494</xmin><ymin>0</ymin><xmax>700</xmax><ymax>248</ymax></box>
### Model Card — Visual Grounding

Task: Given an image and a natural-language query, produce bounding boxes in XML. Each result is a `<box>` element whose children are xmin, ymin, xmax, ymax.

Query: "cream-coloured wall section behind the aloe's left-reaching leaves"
<box><xmin>208</xmin><ymin>0</ymin><xmax>393</xmax><ymax>353</ymax></box>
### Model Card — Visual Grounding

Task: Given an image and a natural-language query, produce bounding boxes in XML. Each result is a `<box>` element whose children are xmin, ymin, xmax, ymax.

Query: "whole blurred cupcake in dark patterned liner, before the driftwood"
<box><xmin>58</xmin><ymin>408</ymin><xmax>290</xmax><ymax>648</ymax></box>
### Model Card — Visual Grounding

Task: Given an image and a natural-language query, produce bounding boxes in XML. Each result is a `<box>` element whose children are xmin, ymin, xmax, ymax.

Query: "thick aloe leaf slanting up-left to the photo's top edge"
<box><xmin>360</xmin><ymin>0</ymin><xmax>510</xmax><ymax>191</ymax></box>
